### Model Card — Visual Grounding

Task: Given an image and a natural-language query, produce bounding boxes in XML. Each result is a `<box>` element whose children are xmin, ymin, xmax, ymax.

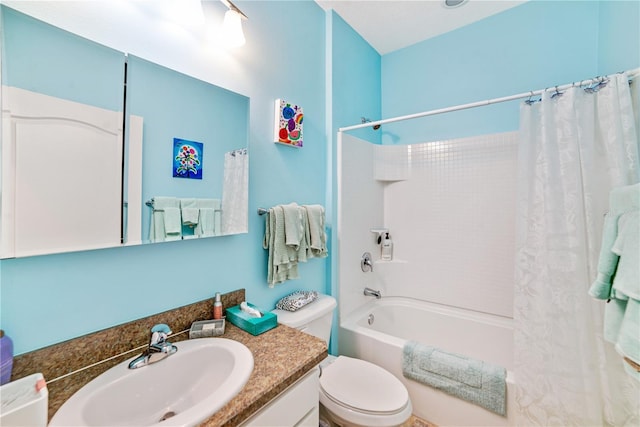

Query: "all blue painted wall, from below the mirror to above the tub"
<box><xmin>0</xmin><ymin>0</ymin><xmax>640</xmax><ymax>354</ymax></box>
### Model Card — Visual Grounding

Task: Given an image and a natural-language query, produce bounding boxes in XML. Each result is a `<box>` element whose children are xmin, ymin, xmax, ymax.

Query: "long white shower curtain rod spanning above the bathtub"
<box><xmin>338</xmin><ymin>68</ymin><xmax>640</xmax><ymax>132</ymax></box>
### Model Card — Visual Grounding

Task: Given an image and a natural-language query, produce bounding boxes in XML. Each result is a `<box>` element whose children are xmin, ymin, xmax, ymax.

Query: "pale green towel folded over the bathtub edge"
<box><xmin>402</xmin><ymin>341</ymin><xmax>507</xmax><ymax>416</ymax></box>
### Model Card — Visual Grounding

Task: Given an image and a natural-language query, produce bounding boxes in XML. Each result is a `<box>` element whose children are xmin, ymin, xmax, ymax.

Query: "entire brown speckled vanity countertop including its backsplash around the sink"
<box><xmin>11</xmin><ymin>289</ymin><xmax>327</xmax><ymax>427</ymax></box>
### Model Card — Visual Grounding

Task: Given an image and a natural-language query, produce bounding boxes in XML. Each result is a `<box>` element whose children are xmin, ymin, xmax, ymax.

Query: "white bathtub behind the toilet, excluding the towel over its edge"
<box><xmin>338</xmin><ymin>297</ymin><xmax>515</xmax><ymax>427</ymax></box>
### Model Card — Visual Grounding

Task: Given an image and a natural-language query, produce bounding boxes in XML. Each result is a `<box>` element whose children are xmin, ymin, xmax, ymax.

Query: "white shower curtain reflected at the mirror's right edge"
<box><xmin>222</xmin><ymin>148</ymin><xmax>249</xmax><ymax>235</ymax></box>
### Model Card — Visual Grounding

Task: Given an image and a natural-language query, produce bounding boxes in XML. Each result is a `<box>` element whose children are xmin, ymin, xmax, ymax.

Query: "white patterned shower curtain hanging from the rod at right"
<box><xmin>514</xmin><ymin>75</ymin><xmax>640</xmax><ymax>426</ymax></box>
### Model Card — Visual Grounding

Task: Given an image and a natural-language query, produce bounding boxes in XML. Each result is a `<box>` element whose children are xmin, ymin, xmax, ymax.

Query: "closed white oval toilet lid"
<box><xmin>320</xmin><ymin>356</ymin><xmax>409</xmax><ymax>413</ymax></box>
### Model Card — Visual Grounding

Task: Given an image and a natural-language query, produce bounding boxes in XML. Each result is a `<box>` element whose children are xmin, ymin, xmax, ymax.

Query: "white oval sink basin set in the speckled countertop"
<box><xmin>49</xmin><ymin>338</ymin><xmax>253</xmax><ymax>427</ymax></box>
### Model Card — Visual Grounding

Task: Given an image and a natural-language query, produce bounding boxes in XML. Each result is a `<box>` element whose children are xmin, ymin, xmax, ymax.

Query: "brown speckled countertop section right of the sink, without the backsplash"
<box><xmin>201</xmin><ymin>322</ymin><xmax>327</xmax><ymax>427</ymax></box>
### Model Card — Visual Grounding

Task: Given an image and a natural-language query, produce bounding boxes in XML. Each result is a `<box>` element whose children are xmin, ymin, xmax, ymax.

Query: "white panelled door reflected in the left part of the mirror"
<box><xmin>1</xmin><ymin>87</ymin><xmax>122</xmax><ymax>258</ymax></box>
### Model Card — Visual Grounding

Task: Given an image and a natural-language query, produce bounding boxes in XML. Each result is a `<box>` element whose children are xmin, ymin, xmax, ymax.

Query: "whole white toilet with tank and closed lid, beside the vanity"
<box><xmin>273</xmin><ymin>295</ymin><xmax>412</xmax><ymax>427</ymax></box>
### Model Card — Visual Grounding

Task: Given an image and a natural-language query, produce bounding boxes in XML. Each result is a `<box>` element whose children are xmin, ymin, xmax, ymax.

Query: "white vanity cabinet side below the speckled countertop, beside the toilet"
<box><xmin>242</xmin><ymin>367</ymin><xmax>320</xmax><ymax>427</ymax></box>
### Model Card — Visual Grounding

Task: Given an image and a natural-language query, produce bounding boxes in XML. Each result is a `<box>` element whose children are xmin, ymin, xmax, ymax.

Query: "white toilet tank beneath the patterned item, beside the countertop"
<box><xmin>272</xmin><ymin>294</ymin><xmax>336</xmax><ymax>345</ymax></box>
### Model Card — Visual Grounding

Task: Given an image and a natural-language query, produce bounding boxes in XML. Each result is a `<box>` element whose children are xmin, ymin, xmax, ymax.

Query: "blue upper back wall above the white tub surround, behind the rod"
<box><xmin>382</xmin><ymin>1</ymin><xmax>640</xmax><ymax>144</ymax></box>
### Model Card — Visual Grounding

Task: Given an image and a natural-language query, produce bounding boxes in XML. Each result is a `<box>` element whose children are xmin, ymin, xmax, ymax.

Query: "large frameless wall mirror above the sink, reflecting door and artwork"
<box><xmin>0</xmin><ymin>5</ymin><xmax>249</xmax><ymax>258</ymax></box>
